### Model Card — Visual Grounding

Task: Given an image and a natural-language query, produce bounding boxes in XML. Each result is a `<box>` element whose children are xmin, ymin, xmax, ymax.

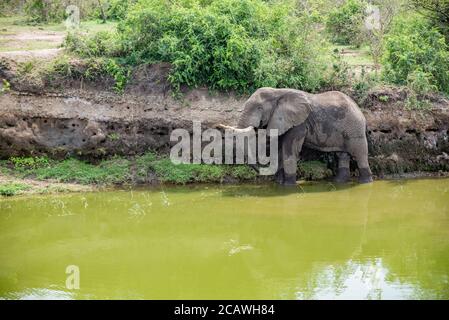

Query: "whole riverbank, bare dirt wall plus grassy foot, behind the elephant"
<box><xmin>0</xmin><ymin>55</ymin><xmax>449</xmax><ymax>193</ymax></box>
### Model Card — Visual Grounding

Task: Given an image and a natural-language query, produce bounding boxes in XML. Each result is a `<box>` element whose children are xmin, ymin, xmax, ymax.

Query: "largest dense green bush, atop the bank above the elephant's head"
<box><xmin>110</xmin><ymin>0</ymin><xmax>330</xmax><ymax>91</ymax></box>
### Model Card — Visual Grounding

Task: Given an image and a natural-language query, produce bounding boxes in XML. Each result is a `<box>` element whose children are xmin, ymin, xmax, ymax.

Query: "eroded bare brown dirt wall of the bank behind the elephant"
<box><xmin>0</xmin><ymin>61</ymin><xmax>449</xmax><ymax>177</ymax></box>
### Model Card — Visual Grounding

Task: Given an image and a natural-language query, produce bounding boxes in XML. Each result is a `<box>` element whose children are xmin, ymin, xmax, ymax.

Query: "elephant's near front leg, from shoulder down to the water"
<box><xmin>281</xmin><ymin>124</ymin><xmax>307</xmax><ymax>185</ymax></box>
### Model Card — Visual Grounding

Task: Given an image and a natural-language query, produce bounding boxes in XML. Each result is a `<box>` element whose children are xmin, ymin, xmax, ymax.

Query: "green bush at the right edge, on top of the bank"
<box><xmin>382</xmin><ymin>16</ymin><xmax>449</xmax><ymax>93</ymax></box>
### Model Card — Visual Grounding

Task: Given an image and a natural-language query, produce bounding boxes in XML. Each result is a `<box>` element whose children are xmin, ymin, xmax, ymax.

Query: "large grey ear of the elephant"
<box><xmin>267</xmin><ymin>92</ymin><xmax>311</xmax><ymax>135</ymax></box>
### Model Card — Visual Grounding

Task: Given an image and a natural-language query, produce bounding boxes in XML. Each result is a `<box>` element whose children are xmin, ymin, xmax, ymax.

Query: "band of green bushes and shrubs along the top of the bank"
<box><xmin>0</xmin><ymin>0</ymin><xmax>449</xmax><ymax>109</ymax></box>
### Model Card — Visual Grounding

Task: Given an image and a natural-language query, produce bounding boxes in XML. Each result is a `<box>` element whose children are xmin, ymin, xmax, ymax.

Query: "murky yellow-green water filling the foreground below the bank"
<box><xmin>0</xmin><ymin>179</ymin><xmax>449</xmax><ymax>299</ymax></box>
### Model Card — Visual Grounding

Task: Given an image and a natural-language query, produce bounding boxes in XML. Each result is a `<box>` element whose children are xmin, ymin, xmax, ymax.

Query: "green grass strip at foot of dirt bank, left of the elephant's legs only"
<box><xmin>0</xmin><ymin>152</ymin><xmax>258</xmax><ymax>185</ymax></box>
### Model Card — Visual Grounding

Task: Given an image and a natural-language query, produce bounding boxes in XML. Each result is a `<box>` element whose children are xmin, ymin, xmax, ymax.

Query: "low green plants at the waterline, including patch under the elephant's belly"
<box><xmin>0</xmin><ymin>152</ymin><xmax>332</xmax><ymax>196</ymax></box>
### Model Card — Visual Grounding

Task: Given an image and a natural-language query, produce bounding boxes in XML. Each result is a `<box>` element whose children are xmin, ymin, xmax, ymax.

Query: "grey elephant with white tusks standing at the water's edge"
<box><xmin>220</xmin><ymin>88</ymin><xmax>373</xmax><ymax>185</ymax></box>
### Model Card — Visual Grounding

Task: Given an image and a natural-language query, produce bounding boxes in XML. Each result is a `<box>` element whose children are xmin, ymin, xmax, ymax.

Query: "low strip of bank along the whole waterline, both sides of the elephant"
<box><xmin>0</xmin><ymin>152</ymin><xmax>449</xmax><ymax>199</ymax></box>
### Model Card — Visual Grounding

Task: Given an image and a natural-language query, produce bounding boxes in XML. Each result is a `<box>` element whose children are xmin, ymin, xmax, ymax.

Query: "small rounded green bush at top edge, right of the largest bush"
<box><xmin>326</xmin><ymin>0</ymin><xmax>367</xmax><ymax>46</ymax></box>
